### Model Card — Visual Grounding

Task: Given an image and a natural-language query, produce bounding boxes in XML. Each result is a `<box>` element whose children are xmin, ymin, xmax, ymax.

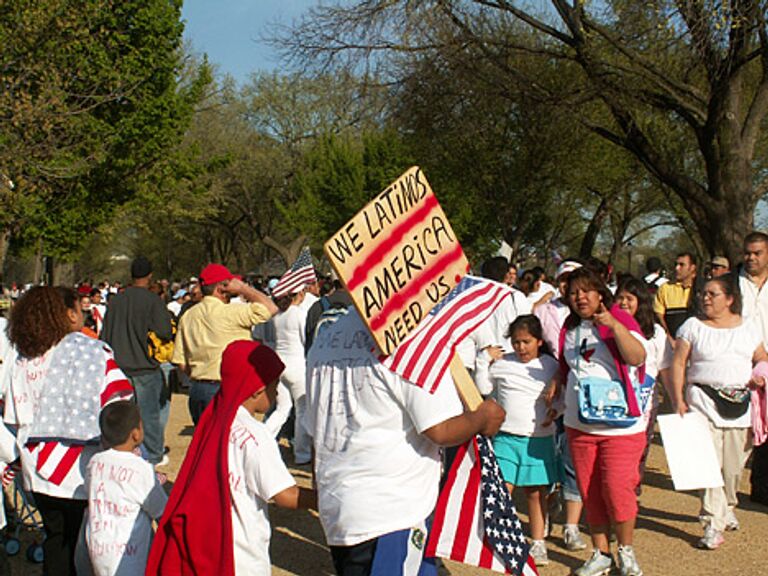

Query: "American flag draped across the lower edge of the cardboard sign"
<box><xmin>381</xmin><ymin>276</ymin><xmax>512</xmax><ymax>392</ymax></box>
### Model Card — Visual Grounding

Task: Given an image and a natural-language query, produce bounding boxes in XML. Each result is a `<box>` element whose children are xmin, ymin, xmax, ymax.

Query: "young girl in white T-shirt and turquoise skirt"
<box><xmin>490</xmin><ymin>314</ymin><xmax>560</xmax><ymax>566</ymax></box>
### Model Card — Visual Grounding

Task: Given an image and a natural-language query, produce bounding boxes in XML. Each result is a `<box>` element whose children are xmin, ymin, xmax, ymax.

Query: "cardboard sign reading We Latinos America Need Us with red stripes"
<box><xmin>324</xmin><ymin>166</ymin><xmax>469</xmax><ymax>355</ymax></box>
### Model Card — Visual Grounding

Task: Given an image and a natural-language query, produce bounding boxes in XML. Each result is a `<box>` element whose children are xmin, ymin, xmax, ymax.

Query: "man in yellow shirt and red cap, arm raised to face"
<box><xmin>171</xmin><ymin>264</ymin><xmax>277</xmax><ymax>424</ymax></box>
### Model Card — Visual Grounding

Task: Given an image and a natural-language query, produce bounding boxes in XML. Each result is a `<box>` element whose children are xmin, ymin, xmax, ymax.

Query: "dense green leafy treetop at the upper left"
<box><xmin>0</xmin><ymin>0</ymin><xmax>209</xmax><ymax>272</ymax></box>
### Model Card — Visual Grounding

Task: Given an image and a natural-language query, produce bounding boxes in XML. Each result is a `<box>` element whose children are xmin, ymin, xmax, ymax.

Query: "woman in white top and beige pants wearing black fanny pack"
<box><xmin>672</xmin><ymin>274</ymin><xmax>768</xmax><ymax>550</ymax></box>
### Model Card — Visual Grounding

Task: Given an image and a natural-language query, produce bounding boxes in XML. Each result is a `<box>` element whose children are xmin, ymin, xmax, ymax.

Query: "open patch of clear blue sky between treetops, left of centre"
<box><xmin>182</xmin><ymin>0</ymin><xmax>319</xmax><ymax>83</ymax></box>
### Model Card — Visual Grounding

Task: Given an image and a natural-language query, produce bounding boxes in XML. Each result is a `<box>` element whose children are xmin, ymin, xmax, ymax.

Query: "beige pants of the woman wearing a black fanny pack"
<box><xmin>700</xmin><ymin>420</ymin><xmax>752</xmax><ymax>532</ymax></box>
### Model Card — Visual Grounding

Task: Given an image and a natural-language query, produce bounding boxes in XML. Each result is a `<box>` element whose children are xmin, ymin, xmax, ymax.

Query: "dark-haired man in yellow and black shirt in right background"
<box><xmin>653</xmin><ymin>252</ymin><xmax>696</xmax><ymax>341</ymax></box>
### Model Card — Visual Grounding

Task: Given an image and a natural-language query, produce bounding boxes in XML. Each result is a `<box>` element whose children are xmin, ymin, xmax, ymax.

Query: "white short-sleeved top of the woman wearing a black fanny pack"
<box><xmin>677</xmin><ymin>318</ymin><xmax>763</xmax><ymax>428</ymax></box>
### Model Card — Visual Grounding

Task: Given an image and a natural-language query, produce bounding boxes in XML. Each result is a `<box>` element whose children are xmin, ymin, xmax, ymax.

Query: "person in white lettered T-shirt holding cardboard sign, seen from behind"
<box><xmin>305</xmin><ymin>310</ymin><xmax>504</xmax><ymax>576</ymax></box>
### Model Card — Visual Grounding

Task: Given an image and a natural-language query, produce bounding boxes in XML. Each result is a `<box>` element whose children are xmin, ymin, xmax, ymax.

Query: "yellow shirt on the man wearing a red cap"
<box><xmin>171</xmin><ymin>296</ymin><xmax>271</xmax><ymax>380</ymax></box>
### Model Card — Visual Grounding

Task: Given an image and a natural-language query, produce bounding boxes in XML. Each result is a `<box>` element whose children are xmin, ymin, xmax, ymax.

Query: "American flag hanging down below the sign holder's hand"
<box><xmin>425</xmin><ymin>436</ymin><xmax>538</xmax><ymax>576</ymax></box>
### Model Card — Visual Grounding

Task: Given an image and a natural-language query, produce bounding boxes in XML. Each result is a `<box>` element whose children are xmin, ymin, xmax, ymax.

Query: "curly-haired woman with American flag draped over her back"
<box><xmin>5</xmin><ymin>286</ymin><xmax>133</xmax><ymax>574</ymax></box>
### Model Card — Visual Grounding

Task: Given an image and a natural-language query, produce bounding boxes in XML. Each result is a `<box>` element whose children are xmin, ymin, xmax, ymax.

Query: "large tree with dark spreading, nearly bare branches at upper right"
<box><xmin>281</xmin><ymin>0</ymin><xmax>768</xmax><ymax>260</ymax></box>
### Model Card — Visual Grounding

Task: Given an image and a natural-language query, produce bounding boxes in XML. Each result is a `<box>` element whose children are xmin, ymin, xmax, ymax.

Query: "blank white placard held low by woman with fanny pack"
<box><xmin>658</xmin><ymin>412</ymin><xmax>723</xmax><ymax>490</ymax></box>
